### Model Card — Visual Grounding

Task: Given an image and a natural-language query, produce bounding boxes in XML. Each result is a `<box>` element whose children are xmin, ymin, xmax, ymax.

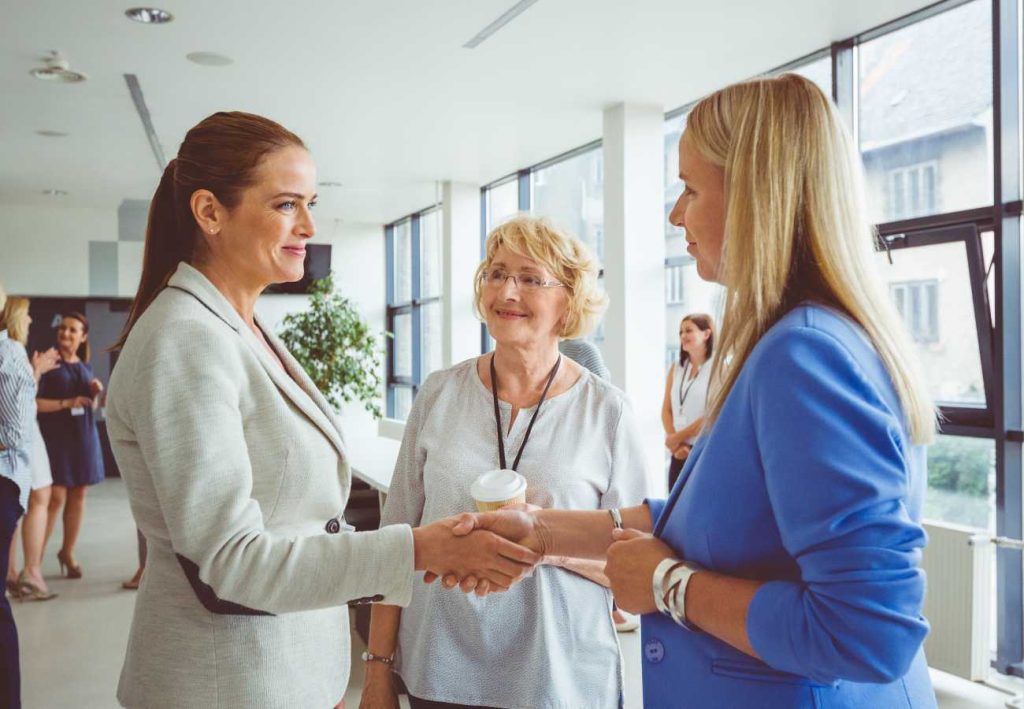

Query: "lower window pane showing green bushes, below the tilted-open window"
<box><xmin>924</xmin><ymin>435</ymin><xmax>995</xmax><ymax>532</ymax></box>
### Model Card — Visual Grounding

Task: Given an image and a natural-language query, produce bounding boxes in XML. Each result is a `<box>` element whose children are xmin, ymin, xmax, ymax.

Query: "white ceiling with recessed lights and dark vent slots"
<box><xmin>0</xmin><ymin>0</ymin><xmax>927</xmax><ymax>222</ymax></box>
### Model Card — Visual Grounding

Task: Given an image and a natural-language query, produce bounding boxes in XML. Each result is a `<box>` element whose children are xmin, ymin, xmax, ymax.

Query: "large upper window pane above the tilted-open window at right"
<box><xmin>859</xmin><ymin>0</ymin><xmax>992</xmax><ymax>222</ymax></box>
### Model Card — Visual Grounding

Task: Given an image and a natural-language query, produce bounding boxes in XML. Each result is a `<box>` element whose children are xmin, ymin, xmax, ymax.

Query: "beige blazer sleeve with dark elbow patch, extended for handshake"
<box><xmin>128</xmin><ymin>320</ymin><xmax>414</xmax><ymax>615</ymax></box>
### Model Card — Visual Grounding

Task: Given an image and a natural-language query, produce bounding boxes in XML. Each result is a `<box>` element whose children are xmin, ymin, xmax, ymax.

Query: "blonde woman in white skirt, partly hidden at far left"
<box><xmin>0</xmin><ymin>297</ymin><xmax>59</xmax><ymax>600</ymax></box>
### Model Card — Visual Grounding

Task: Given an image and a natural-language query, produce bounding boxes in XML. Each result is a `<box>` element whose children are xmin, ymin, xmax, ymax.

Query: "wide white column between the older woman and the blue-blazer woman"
<box><xmin>603</xmin><ymin>103</ymin><xmax>667</xmax><ymax>494</ymax></box>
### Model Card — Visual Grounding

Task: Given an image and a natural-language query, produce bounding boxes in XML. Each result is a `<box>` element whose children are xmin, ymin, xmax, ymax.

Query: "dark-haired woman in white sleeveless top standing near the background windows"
<box><xmin>662</xmin><ymin>312</ymin><xmax>715</xmax><ymax>490</ymax></box>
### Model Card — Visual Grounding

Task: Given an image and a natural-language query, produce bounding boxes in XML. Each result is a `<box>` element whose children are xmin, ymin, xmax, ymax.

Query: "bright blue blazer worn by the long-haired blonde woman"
<box><xmin>641</xmin><ymin>305</ymin><xmax>936</xmax><ymax>709</ymax></box>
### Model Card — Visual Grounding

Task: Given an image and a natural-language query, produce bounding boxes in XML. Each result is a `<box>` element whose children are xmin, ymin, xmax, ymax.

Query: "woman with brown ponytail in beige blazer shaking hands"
<box><xmin>108</xmin><ymin>113</ymin><xmax>541</xmax><ymax>707</ymax></box>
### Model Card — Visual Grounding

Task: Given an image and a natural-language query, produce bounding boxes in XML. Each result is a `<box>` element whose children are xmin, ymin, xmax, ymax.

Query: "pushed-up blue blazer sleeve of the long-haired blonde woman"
<box><xmin>746</xmin><ymin>328</ymin><xmax>928</xmax><ymax>683</ymax></box>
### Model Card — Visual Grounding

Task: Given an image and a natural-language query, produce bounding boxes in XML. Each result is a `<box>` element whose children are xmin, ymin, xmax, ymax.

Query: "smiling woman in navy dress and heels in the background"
<box><xmin>37</xmin><ymin>312</ymin><xmax>104</xmax><ymax>579</ymax></box>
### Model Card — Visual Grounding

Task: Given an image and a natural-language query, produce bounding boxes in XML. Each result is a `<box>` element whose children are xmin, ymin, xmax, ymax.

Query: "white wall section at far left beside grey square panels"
<box><xmin>0</xmin><ymin>205</ymin><xmax>117</xmax><ymax>297</ymax></box>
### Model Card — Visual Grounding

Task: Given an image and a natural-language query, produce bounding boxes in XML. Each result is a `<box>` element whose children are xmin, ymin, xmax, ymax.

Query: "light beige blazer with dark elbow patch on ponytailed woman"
<box><xmin>106</xmin><ymin>263</ymin><xmax>414</xmax><ymax>709</ymax></box>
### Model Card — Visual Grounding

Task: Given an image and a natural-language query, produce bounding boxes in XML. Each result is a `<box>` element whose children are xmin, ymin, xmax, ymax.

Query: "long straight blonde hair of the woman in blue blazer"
<box><xmin>683</xmin><ymin>74</ymin><xmax>936</xmax><ymax>444</ymax></box>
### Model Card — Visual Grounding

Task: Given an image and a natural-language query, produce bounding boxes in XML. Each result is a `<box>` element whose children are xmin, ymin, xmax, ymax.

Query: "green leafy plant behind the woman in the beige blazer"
<box><xmin>279</xmin><ymin>273</ymin><xmax>384</xmax><ymax>418</ymax></box>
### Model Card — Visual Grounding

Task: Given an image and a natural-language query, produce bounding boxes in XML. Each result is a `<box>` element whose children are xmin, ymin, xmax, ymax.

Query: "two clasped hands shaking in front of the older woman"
<box><xmin>413</xmin><ymin>504</ymin><xmax>551</xmax><ymax>596</ymax></box>
